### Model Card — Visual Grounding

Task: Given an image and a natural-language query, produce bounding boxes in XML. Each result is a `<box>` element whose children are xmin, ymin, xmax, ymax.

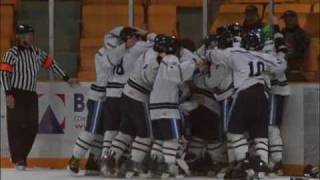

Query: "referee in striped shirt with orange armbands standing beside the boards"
<box><xmin>0</xmin><ymin>24</ymin><xmax>76</xmax><ymax>170</ymax></box>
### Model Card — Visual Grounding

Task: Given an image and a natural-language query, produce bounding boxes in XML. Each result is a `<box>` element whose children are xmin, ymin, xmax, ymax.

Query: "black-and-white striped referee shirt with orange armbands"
<box><xmin>0</xmin><ymin>46</ymin><xmax>69</xmax><ymax>94</ymax></box>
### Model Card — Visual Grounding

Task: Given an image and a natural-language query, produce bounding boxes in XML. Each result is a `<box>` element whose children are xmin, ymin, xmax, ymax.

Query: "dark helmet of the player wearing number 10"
<box><xmin>241</xmin><ymin>31</ymin><xmax>264</xmax><ymax>51</ymax></box>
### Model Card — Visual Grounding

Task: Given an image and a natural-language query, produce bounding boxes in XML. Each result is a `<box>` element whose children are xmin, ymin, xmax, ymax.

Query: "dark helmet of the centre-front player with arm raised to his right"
<box><xmin>153</xmin><ymin>34</ymin><xmax>179</xmax><ymax>54</ymax></box>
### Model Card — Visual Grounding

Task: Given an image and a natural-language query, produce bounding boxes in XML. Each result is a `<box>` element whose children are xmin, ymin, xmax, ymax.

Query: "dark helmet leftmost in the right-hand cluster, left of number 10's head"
<box><xmin>216</xmin><ymin>26</ymin><xmax>233</xmax><ymax>49</ymax></box>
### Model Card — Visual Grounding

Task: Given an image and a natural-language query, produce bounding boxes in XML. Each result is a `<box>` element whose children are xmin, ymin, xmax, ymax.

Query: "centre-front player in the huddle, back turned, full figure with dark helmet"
<box><xmin>149</xmin><ymin>35</ymin><xmax>204</xmax><ymax>177</ymax></box>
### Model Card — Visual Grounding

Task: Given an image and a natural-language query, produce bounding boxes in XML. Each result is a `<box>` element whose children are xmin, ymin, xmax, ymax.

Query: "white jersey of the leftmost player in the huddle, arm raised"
<box><xmin>88</xmin><ymin>26</ymin><xmax>123</xmax><ymax>101</ymax></box>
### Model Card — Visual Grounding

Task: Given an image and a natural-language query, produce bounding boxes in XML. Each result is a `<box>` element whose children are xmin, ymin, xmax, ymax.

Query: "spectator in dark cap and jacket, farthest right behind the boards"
<box><xmin>281</xmin><ymin>10</ymin><xmax>310</xmax><ymax>81</ymax></box>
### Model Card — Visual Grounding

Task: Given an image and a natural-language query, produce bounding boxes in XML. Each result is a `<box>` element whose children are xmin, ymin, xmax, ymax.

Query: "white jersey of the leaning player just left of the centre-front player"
<box><xmin>123</xmin><ymin>48</ymin><xmax>159</xmax><ymax>103</ymax></box>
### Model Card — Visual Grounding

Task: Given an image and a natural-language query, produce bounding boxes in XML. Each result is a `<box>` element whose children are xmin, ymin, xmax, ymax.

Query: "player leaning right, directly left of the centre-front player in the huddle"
<box><xmin>100</xmin><ymin>35</ymin><xmax>163</xmax><ymax>176</ymax></box>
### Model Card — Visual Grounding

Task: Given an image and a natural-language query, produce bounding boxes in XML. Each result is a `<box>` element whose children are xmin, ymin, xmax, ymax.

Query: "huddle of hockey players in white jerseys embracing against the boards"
<box><xmin>68</xmin><ymin>23</ymin><xmax>289</xmax><ymax>179</ymax></box>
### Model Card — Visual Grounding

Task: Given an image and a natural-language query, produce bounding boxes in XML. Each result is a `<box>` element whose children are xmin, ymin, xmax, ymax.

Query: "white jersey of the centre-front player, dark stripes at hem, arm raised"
<box><xmin>149</xmin><ymin>49</ymin><xmax>198</xmax><ymax>120</ymax></box>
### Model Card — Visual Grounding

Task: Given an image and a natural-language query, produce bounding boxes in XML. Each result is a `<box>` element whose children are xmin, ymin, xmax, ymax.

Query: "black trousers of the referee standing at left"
<box><xmin>7</xmin><ymin>90</ymin><xmax>38</xmax><ymax>163</ymax></box>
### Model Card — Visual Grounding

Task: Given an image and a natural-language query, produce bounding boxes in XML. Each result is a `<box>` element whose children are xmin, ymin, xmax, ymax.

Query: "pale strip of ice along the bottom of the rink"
<box><xmin>1</xmin><ymin>169</ymin><xmax>311</xmax><ymax>180</ymax></box>
